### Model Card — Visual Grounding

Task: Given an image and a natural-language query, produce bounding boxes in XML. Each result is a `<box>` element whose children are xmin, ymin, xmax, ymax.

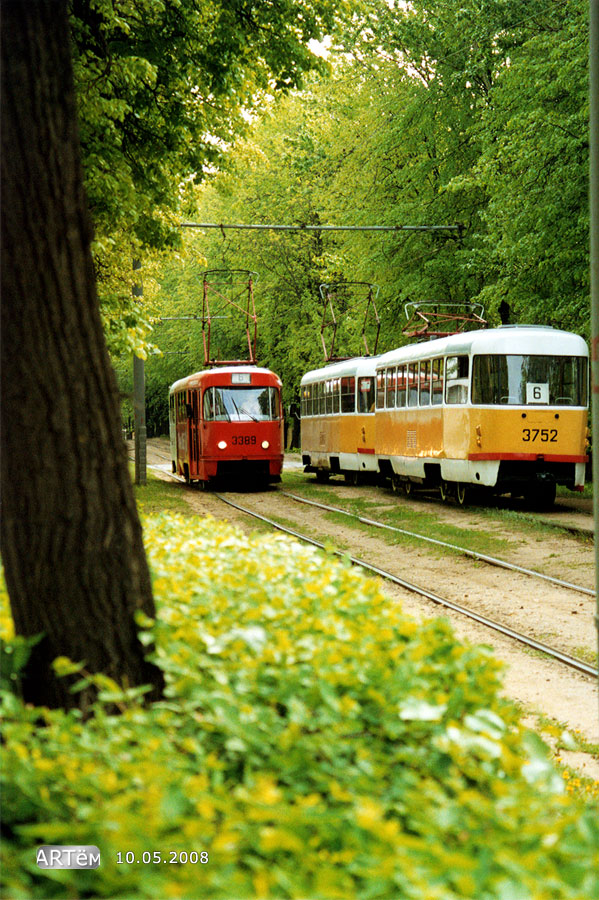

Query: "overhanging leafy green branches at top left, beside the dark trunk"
<box><xmin>70</xmin><ymin>0</ymin><xmax>346</xmax><ymax>246</ymax></box>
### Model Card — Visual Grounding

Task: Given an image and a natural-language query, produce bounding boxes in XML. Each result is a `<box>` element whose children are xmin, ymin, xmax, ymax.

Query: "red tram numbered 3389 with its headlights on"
<box><xmin>169</xmin><ymin>365</ymin><xmax>283</xmax><ymax>487</ymax></box>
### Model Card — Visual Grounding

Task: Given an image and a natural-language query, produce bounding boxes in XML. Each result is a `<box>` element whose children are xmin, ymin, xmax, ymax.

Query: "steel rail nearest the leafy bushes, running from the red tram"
<box><xmin>212</xmin><ymin>493</ymin><xmax>599</xmax><ymax>678</ymax></box>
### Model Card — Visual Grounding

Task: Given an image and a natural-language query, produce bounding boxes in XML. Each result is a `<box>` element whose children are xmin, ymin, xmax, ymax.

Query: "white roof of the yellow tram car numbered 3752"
<box><xmin>376</xmin><ymin>325</ymin><xmax>588</xmax><ymax>369</ymax></box>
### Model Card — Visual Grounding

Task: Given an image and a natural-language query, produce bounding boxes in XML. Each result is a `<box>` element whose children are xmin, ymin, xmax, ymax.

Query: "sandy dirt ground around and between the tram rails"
<box><xmin>142</xmin><ymin>440</ymin><xmax>599</xmax><ymax>780</ymax></box>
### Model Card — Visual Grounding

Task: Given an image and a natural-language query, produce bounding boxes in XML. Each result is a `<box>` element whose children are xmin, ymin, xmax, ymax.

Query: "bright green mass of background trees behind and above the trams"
<box><xmin>110</xmin><ymin>0</ymin><xmax>588</xmax><ymax>414</ymax></box>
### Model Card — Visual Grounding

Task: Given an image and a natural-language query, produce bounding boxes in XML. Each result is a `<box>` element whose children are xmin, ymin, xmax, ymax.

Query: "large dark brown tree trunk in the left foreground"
<box><xmin>1</xmin><ymin>0</ymin><xmax>162</xmax><ymax>707</ymax></box>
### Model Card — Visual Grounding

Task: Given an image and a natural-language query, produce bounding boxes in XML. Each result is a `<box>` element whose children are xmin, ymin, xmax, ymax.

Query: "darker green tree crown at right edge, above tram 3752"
<box><xmin>472</xmin><ymin>2</ymin><xmax>589</xmax><ymax>330</ymax></box>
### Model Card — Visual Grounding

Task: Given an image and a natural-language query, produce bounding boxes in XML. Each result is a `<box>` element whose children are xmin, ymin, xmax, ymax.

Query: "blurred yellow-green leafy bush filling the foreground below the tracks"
<box><xmin>0</xmin><ymin>516</ymin><xmax>599</xmax><ymax>900</ymax></box>
